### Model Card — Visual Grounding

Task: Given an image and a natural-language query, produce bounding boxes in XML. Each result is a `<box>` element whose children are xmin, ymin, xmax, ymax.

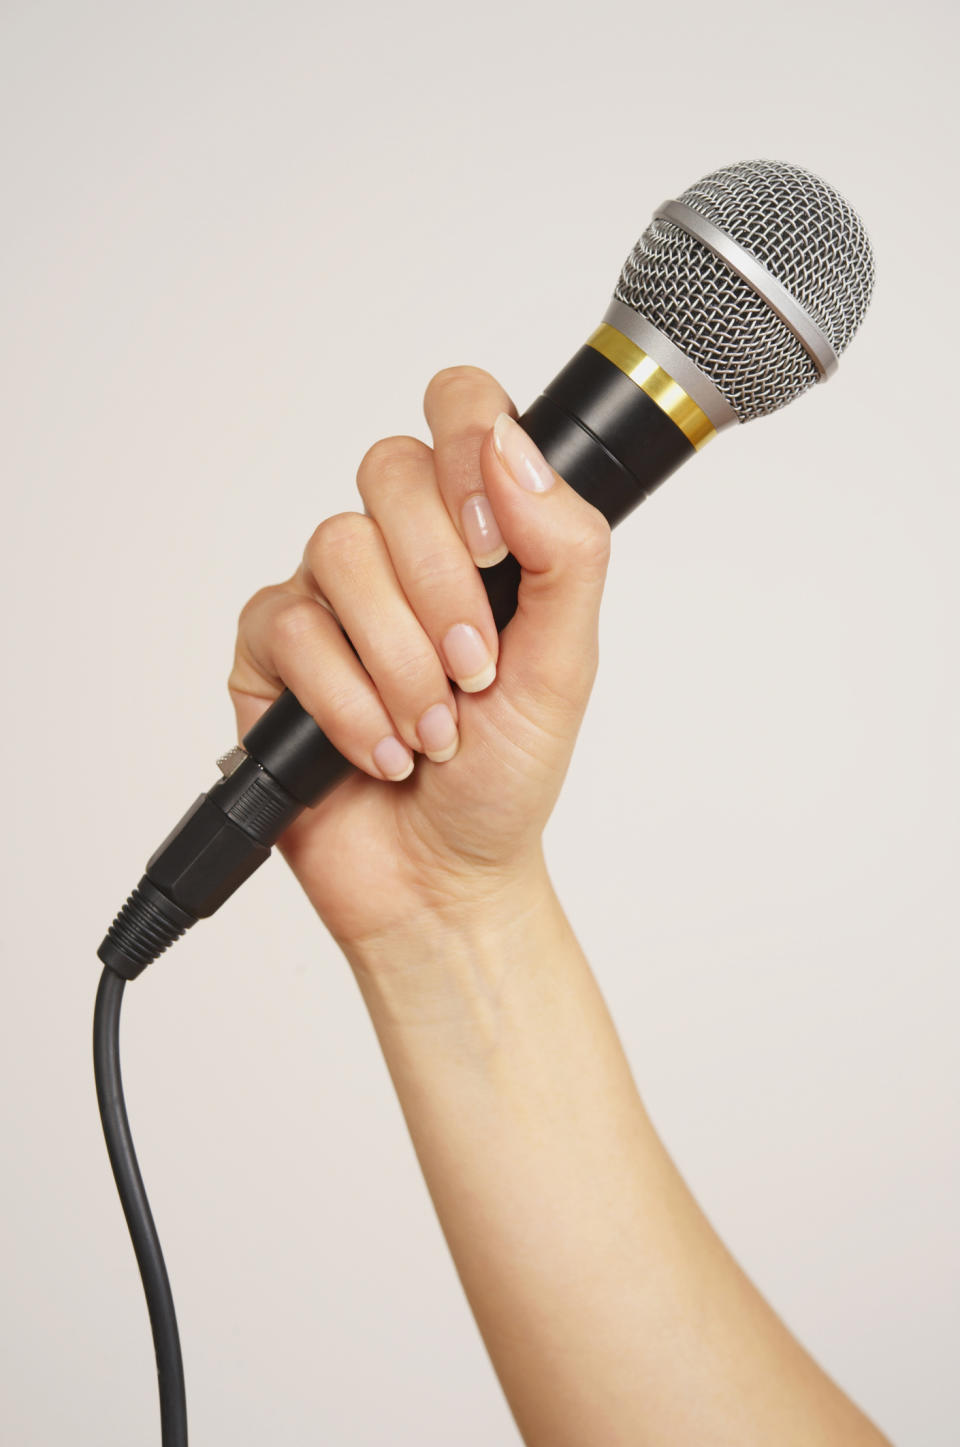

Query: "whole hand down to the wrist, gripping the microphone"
<box><xmin>229</xmin><ymin>368</ymin><xmax>610</xmax><ymax>949</ymax></box>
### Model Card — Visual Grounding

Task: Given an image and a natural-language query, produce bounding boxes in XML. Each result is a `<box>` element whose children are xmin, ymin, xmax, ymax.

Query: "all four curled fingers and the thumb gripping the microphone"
<box><xmin>230</xmin><ymin>368</ymin><xmax>610</xmax><ymax>778</ymax></box>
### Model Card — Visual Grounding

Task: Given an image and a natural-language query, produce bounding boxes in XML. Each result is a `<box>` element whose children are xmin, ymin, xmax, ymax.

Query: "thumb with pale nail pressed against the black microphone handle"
<box><xmin>481</xmin><ymin>412</ymin><xmax>610</xmax><ymax>715</ymax></box>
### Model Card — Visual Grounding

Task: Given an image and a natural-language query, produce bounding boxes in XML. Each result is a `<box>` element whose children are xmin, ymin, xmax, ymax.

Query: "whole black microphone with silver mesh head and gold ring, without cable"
<box><xmin>97</xmin><ymin>161</ymin><xmax>873</xmax><ymax>980</ymax></box>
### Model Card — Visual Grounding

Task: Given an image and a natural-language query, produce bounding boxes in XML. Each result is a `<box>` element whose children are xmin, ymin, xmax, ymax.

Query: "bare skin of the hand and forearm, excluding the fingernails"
<box><xmin>230</xmin><ymin>368</ymin><xmax>886</xmax><ymax>1447</ymax></box>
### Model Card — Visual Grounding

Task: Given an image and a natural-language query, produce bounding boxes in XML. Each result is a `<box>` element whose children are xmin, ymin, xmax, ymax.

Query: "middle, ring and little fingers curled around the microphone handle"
<box><xmin>233</xmin><ymin>410</ymin><xmax>509</xmax><ymax>777</ymax></box>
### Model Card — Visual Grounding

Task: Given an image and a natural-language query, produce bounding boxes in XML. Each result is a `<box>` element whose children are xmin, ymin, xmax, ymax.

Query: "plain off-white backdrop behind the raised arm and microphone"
<box><xmin>0</xmin><ymin>0</ymin><xmax>960</xmax><ymax>1447</ymax></box>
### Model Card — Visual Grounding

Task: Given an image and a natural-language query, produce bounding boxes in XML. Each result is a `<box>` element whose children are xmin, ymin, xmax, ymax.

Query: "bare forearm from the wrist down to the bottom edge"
<box><xmin>341</xmin><ymin>871</ymin><xmax>883</xmax><ymax>1447</ymax></box>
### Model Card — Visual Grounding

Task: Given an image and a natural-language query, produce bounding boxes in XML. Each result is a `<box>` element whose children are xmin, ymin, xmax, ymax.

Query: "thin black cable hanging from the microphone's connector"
<box><xmin>93</xmin><ymin>967</ymin><xmax>187</xmax><ymax>1447</ymax></box>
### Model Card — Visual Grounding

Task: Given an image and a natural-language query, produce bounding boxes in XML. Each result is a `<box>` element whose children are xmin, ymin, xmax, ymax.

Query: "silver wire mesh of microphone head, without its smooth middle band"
<box><xmin>614</xmin><ymin>161</ymin><xmax>873</xmax><ymax>423</ymax></box>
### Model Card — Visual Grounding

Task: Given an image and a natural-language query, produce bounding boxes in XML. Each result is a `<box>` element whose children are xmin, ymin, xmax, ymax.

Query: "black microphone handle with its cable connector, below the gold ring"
<box><xmin>97</xmin><ymin>344</ymin><xmax>696</xmax><ymax>980</ymax></box>
